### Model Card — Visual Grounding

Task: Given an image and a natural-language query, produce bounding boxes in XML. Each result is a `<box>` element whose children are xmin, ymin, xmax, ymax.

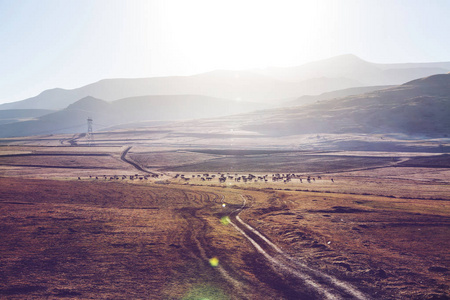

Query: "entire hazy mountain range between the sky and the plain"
<box><xmin>0</xmin><ymin>55</ymin><xmax>450</xmax><ymax>137</ymax></box>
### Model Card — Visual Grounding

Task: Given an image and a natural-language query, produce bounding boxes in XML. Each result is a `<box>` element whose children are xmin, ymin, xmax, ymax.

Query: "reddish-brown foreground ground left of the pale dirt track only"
<box><xmin>0</xmin><ymin>178</ymin><xmax>302</xmax><ymax>299</ymax></box>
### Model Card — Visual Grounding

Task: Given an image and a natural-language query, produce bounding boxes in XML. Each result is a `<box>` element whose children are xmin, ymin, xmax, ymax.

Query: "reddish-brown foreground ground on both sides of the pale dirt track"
<box><xmin>0</xmin><ymin>178</ymin><xmax>450</xmax><ymax>299</ymax></box>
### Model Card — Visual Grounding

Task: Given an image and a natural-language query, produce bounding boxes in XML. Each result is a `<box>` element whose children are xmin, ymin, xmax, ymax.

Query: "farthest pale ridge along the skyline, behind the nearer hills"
<box><xmin>0</xmin><ymin>54</ymin><xmax>450</xmax><ymax>110</ymax></box>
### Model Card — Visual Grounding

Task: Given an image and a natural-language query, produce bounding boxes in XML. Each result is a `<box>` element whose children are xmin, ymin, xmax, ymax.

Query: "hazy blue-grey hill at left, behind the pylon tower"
<box><xmin>0</xmin><ymin>95</ymin><xmax>264</xmax><ymax>137</ymax></box>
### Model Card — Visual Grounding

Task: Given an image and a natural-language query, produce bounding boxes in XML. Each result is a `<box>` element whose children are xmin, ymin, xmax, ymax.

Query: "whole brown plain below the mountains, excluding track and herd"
<box><xmin>0</xmin><ymin>138</ymin><xmax>450</xmax><ymax>299</ymax></box>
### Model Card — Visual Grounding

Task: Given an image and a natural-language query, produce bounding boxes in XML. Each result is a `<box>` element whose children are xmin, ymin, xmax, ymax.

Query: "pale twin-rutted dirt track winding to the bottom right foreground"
<box><xmin>230</xmin><ymin>195</ymin><xmax>370</xmax><ymax>300</ymax></box>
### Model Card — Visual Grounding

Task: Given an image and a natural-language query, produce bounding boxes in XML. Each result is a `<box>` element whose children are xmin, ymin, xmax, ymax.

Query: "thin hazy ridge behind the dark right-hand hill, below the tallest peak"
<box><xmin>279</xmin><ymin>85</ymin><xmax>392</xmax><ymax>107</ymax></box>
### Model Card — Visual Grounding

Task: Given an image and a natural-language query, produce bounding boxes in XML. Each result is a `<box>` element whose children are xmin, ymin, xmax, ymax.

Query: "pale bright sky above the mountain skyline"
<box><xmin>0</xmin><ymin>0</ymin><xmax>450</xmax><ymax>103</ymax></box>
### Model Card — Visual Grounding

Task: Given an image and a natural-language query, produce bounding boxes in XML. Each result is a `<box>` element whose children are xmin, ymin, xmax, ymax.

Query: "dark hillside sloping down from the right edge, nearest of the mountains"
<box><xmin>234</xmin><ymin>74</ymin><xmax>450</xmax><ymax>136</ymax></box>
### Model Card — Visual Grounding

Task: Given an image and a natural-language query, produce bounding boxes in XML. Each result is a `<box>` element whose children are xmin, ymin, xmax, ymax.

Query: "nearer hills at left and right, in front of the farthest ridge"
<box><xmin>0</xmin><ymin>73</ymin><xmax>450</xmax><ymax>137</ymax></box>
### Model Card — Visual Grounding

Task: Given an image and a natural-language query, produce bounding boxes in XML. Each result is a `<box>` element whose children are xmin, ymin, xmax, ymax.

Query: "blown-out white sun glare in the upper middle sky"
<box><xmin>134</xmin><ymin>0</ymin><xmax>342</xmax><ymax>69</ymax></box>
